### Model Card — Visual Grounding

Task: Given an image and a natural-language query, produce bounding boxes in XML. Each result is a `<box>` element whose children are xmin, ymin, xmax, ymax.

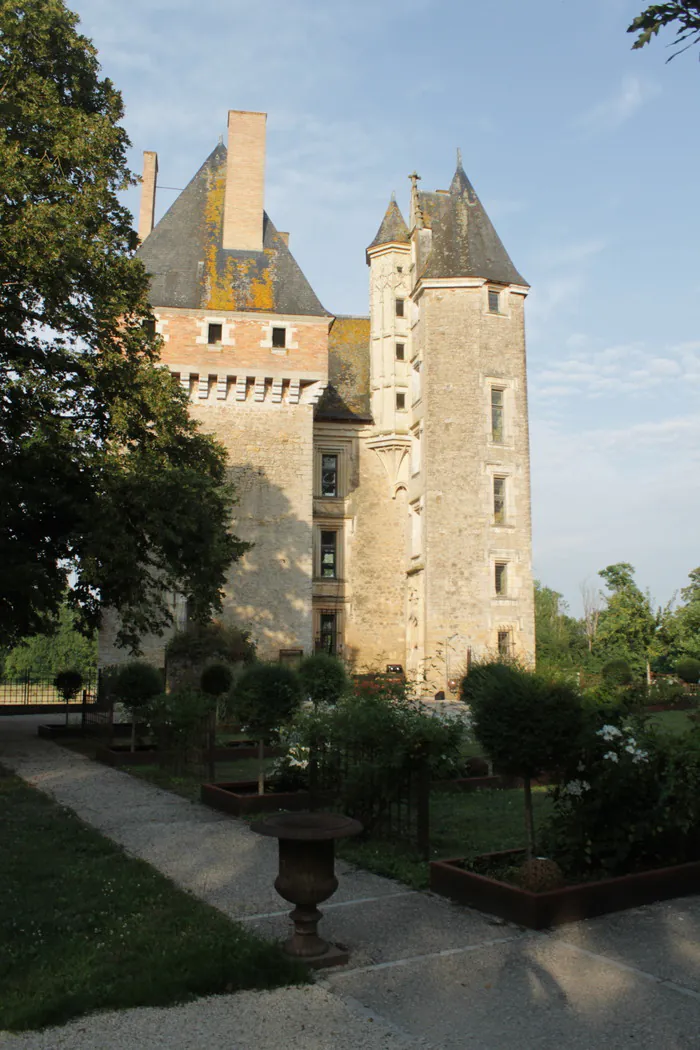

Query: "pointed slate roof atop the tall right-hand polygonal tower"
<box><xmin>421</xmin><ymin>164</ymin><xmax>528</xmax><ymax>287</ymax></box>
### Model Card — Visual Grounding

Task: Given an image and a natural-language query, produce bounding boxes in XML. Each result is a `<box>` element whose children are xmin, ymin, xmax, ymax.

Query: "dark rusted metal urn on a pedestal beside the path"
<box><xmin>251</xmin><ymin>813</ymin><xmax>362</xmax><ymax>967</ymax></box>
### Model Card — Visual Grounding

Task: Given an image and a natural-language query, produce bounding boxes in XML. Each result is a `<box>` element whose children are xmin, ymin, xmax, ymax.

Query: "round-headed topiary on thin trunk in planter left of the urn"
<box><xmin>229</xmin><ymin>664</ymin><xmax>301</xmax><ymax>795</ymax></box>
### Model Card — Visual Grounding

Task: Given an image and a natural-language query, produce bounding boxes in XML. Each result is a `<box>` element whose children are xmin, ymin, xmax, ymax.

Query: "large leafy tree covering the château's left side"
<box><xmin>0</xmin><ymin>0</ymin><xmax>246</xmax><ymax>645</ymax></box>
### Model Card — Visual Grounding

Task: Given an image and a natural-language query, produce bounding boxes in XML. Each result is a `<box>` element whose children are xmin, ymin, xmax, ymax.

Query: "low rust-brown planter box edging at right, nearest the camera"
<box><xmin>430</xmin><ymin>849</ymin><xmax>700</xmax><ymax>929</ymax></box>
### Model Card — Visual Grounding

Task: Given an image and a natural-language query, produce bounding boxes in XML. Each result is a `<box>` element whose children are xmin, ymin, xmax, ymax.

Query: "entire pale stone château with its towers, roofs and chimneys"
<box><xmin>100</xmin><ymin>110</ymin><xmax>534</xmax><ymax>694</ymax></box>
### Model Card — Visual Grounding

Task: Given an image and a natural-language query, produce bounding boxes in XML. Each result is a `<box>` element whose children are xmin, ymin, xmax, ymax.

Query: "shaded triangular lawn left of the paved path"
<box><xmin>0</xmin><ymin>775</ymin><xmax>309</xmax><ymax>1030</ymax></box>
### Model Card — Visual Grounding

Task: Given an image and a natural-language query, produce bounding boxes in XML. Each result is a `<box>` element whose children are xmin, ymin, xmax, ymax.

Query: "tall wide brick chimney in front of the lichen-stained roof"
<box><xmin>224</xmin><ymin>109</ymin><xmax>268</xmax><ymax>252</ymax></box>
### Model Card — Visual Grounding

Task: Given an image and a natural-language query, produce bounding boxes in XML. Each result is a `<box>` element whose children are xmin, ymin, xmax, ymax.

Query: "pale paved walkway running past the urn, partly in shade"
<box><xmin>0</xmin><ymin>716</ymin><xmax>700</xmax><ymax>1050</ymax></box>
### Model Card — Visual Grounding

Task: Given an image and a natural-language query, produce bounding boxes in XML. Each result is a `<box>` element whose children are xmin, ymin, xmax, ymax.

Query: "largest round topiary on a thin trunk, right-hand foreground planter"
<box><xmin>462</xmin><ymin>663</ymin><xmax>585</xmax><ymax>860</ymax></box>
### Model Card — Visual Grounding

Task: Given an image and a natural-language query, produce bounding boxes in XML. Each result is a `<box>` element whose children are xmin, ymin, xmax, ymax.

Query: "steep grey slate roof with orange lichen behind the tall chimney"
<box><xmin>136</xmin><ymin>143</ymin><xmax>330</xmax><ymax>317</ymax></box>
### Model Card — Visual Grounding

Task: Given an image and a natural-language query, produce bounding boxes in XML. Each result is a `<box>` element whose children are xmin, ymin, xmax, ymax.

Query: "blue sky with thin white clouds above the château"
<box><xmin>69</xmin><ymin>0</ymin><xmax>700</xmax><ymax>612</ymax></box>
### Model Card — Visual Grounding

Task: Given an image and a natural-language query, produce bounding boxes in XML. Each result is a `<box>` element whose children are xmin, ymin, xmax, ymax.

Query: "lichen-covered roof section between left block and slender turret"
<box><xmin>315</xmin><ymin>316</ymin><xmax>372</xmax><ymax>423</ymax></box>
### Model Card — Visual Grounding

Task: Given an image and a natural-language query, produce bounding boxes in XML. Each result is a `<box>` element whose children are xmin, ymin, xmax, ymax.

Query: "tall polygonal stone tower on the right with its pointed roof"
<box><xmin>398</xmin><ymin>160</ymin><xmax>534</xmax><ymax>689</ymax></box>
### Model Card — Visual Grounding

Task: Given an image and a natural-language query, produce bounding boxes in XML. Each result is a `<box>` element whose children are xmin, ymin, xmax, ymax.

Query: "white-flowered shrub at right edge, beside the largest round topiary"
<box><xmin>544</xmin><ymin>721</ymin><xmax>700</xmax><ymax>877</ymax></box>
